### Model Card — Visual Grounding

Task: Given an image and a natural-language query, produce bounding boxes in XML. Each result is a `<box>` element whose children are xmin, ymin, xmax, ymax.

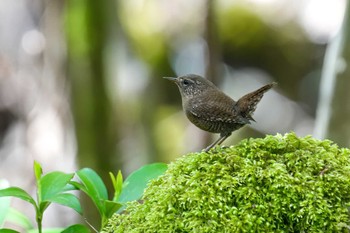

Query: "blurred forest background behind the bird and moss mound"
<box><xmin>0</xmin><ymin>0</ymin><xmax>350</xmax><ymax>230</ymax></box>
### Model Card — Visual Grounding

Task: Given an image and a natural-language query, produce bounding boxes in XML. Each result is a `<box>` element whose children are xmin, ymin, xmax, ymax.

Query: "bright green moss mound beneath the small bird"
<box><xmin>104</xmin><ymin>133</ymin><xmax>350</xmax><ymax>233</ymax></box>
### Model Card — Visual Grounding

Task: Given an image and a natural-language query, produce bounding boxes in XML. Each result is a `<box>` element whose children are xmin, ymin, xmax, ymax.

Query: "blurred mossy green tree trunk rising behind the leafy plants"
<box><xmin>68</xmin><ymin>0</ymin><xmax>121</xmax><ymax>229</ymax></box>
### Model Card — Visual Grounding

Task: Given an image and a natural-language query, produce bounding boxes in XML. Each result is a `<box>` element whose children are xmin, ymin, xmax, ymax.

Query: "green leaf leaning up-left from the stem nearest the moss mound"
<box><xmin>77</xmin><ymin>168</ymin><xmax>108</xmax><ymax>215</ymax></box>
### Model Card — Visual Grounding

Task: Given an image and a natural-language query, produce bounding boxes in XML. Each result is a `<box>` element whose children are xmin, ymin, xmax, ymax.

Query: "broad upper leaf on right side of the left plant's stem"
<box><xmin>39</xmin><ymin>171</ymin><xmax>74</xmax><ymax>202</ymax></box>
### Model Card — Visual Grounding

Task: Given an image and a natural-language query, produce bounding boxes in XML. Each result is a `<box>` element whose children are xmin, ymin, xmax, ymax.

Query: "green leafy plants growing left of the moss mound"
<box><xmin>0</xmin><ymin>162</ymin><xmax>167</xmax><ymax>233</ymax></box>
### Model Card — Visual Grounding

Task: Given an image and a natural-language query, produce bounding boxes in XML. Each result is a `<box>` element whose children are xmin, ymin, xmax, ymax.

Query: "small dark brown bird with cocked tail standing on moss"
<box><xmin>164</xmin><ymin>74</ymin><xmax>276</xmax><ymax>152</ymax></box>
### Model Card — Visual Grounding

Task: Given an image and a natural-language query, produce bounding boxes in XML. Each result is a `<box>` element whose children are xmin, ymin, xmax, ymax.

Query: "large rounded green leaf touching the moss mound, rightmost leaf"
<box><xmin>118</xmin><ymin>163</ymin><xmax>168</xmax><ymax>203</ymax></box>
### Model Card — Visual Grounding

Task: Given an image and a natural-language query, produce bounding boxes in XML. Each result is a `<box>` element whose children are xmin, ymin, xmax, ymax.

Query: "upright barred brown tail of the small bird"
<box><xmin>233</xmin><ymin>82</ymin><xmax>277</xmax><ymax>123</ymax></box>
